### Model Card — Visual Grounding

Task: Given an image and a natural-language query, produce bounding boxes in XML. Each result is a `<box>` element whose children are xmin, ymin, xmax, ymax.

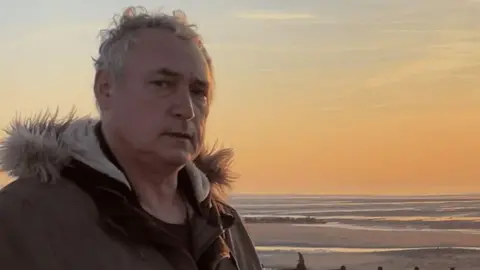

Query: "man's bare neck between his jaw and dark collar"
<box><xmin>101</xmin><ymin>124</ymin><xmax>181</xmax><ymax>205</ymax></box>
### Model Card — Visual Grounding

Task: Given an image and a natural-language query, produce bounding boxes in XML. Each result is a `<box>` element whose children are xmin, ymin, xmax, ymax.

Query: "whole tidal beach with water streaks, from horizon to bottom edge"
<box><xmin>231</xmin><ymin>195</ymin><xmax>480</xmax><ymax>270</ymax></box>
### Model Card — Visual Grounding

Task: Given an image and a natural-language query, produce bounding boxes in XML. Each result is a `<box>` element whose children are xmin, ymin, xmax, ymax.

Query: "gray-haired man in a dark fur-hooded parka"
<box><xmin>0</xmin><ymin>8</ymin><xmax>261</xmax><ymax>270</ymax></box>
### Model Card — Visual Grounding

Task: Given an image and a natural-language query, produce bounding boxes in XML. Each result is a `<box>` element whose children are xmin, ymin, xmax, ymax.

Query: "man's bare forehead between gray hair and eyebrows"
<box><xmin>125</xmin><ymin>29</ymin><xmax>210</xmax><ymax>81</ymax></box>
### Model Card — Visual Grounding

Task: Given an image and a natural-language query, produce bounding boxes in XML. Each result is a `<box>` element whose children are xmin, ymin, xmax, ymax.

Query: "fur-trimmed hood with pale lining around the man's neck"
<box><xmin>0</xmin><ymin>112</ymin><xmax>233</xmax><ymax>201</ymax></box>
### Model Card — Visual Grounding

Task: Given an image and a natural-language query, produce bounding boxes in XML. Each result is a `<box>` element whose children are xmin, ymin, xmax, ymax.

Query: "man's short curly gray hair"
<box><xmin>94</xmin><ymin>7</ymin><xmax>212</xmax><ymax>76</ymax></box>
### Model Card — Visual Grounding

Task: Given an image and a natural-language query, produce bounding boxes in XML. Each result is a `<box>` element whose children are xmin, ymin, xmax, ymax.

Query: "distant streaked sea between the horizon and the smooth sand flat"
<box><xmin>230</xmin><ymin>194</ymin><xmax>480</xmax><ymax>252</ymax></box>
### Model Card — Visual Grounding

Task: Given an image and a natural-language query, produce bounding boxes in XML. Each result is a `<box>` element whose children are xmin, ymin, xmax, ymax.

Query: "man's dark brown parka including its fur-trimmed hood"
<box><xmin>0</xmin><ymin>114</ymin><xmax>261</xmax><ymax>270</ymax></box>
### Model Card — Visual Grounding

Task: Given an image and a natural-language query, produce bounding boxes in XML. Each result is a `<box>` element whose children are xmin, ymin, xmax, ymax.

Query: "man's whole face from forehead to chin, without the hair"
<box><xmin>97</xmin><ymin>29</ymin><xmax>211</xmax><ymax>165</ymax></box>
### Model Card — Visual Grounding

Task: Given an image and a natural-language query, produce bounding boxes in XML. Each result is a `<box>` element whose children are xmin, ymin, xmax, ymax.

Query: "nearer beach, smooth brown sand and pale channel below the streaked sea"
<box><xmin>247</xmin><ymin>224</ymin><xmax>480</xmax><ymax>270</ymax></box>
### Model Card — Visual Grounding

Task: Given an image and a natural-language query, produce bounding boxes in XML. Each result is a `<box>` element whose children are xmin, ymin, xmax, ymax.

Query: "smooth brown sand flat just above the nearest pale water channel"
<box><xmin>247</xmin><ymin>224</ymin><xmax>480</xmax><ymax>248</ymax></box>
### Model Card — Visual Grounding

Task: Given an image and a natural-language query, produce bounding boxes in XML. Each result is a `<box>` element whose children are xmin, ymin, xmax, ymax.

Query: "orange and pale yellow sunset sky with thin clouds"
<box><xmin>0</xmin><ymin>0</ymin><xmax>480</xmax><ymax>194</ymax></box>
